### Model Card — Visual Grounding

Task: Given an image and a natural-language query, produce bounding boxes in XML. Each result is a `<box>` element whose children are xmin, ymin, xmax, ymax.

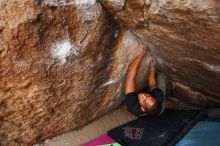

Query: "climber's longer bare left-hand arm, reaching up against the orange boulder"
<box><xmin>125</xmin><ymin>51</ymin><xmax>145</xmax><ymax>94</ymax></box>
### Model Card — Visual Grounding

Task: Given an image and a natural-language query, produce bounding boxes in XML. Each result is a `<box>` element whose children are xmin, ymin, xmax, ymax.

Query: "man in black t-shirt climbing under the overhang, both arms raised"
<box><xmin>125</xmin><ymin>51</ymin><xmax>167</xmax><ymax>116</ymax></box>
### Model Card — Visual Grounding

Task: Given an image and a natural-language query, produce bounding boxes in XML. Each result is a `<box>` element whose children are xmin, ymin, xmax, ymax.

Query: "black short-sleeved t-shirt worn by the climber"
<box><xmin>125</xmin><ymin>88</ymin><xmax>164</xmax><ymax>116</ymax></box>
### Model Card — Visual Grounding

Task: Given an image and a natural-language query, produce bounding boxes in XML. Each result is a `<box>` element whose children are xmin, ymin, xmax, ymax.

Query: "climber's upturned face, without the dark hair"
<box><xmin>138</xmin><ymin>93</ymin><xmax>157</xmax><ymax>112</ymax></box>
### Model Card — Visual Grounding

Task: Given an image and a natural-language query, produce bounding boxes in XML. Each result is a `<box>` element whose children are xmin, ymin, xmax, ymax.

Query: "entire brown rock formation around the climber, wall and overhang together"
<box><xmin>0</xmin><ymin>0</ymin><xmax>220</xmax><ymax>146</ymax></box>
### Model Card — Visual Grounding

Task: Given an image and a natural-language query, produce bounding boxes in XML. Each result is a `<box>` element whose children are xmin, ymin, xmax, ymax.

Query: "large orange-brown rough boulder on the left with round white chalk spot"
<box><xmin>0</xmin><ymin>0</ymin><xmax>150</xmax><ymax>146</ymax></box>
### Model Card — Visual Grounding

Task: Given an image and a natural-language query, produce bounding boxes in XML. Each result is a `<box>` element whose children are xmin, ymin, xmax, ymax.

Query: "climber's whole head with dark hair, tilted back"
<box><xmin>138</xmin><ymin>93</ymin><xmax>161</xmax><ymax>114</ymax></box>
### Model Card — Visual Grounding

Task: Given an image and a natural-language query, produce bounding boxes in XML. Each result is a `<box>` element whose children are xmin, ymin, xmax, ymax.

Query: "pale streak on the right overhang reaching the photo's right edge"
<box><xmin>183</xmin><ymin>57</ymin><xmax>220</xmax><ymax>73</ymax></box>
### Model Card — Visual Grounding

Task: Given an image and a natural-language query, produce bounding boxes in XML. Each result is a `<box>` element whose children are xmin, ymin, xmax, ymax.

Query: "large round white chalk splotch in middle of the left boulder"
<box><xmin>51</xmin><ymin>39</ymin><xmax>78</xmax><ymax>65</ymax></box>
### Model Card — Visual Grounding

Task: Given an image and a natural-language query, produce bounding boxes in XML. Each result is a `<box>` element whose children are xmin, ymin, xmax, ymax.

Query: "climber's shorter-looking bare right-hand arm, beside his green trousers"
<box><xmin>148</xmin><ymin>60</ymin><xmax>157</xmax><ymax>90</ymax></box>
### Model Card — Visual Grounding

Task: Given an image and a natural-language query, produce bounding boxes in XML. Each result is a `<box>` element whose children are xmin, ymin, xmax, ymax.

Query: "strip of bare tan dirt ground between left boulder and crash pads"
<box><xmin>33</xmin><ymin>106</ymin><xmax>135</xmax><ymax>146</ymax></box>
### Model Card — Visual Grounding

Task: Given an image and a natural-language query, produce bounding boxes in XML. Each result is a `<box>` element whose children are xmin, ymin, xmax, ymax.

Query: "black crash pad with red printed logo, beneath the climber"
<box><xmin>108</xmin><ymin>110</ymin><xmax>205</xmax><ymax>146</ymax></box>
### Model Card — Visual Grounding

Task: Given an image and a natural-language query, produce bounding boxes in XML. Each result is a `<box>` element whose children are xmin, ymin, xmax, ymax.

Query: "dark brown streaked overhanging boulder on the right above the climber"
<box><xmin>100</xmin><ymin>0</ymin><xmax>220</xmax><ymax>107</ymax></box>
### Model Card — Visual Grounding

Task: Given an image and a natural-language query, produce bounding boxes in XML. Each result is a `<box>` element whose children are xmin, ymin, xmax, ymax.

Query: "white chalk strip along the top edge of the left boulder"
<box><xmin>42</xmin><ymin>0</ymin><xmax>96</xmax><ymax>6</ymax></box>
